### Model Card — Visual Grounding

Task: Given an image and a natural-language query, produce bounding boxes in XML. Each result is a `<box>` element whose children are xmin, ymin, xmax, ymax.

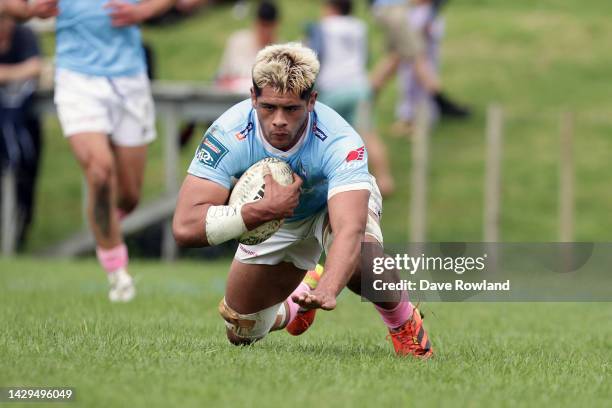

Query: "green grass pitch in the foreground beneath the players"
<box><xmin>0</xmin><ymin>260</ymin><xmax>612</xmax><ymax>408</ymax></box>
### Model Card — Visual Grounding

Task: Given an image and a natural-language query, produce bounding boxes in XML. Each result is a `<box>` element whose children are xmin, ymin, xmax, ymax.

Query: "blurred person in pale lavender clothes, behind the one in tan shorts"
<box><xmin>393</xmin><ymin>0</ymin><xmax>445</xmax><ymax>136</ymax></box>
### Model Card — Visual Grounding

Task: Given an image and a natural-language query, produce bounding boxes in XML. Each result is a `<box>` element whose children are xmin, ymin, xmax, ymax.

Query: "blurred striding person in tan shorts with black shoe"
<box><xmin>371</xmin><ymin>0</ymin><xmax>470</xmax><ymax>125</ymax></box>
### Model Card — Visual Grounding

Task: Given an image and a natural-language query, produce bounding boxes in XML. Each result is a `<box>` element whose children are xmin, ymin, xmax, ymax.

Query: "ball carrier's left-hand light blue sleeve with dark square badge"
<box><xmin>187</xmin><ymin>123</ymin><xmax>245</xmax><ymax>190</ymax></box>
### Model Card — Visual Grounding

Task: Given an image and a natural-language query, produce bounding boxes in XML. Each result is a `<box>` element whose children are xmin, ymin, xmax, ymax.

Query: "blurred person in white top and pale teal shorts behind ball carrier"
<box><xmin>307</xmin><ymin>0</ymin><xmax>395</xmax><ymax>196</ymax></box>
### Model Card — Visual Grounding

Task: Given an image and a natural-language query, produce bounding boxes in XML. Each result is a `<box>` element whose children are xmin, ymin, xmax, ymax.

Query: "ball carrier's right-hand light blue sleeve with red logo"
<box><xmin>323</xmin><ymin>126</ymin><xmax>370</xmax><ymax>199</ymax></box>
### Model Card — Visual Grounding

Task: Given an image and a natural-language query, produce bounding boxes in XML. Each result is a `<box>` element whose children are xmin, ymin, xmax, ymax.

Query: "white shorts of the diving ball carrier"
<box><xmin>234</xmin><ymin>176</ymin><xmax>383</xmax><ymax>270</ymax></box>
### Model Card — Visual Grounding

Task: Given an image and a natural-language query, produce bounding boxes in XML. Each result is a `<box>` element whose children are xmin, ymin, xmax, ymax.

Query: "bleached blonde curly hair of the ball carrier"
<box><xmin>253</xmin><ymin>42</ymin><xmax>320</xmax><ymax>99</ymax></box>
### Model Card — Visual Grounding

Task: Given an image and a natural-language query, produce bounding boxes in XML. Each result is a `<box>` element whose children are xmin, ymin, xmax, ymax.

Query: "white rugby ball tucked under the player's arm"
<box><xmin>229</xmin><ymin>157</ymin><xmax>293</xmax><ymax>245</ymax></box>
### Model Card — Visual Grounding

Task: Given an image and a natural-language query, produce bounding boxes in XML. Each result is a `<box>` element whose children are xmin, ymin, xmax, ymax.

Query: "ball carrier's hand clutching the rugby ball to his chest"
<box><xmin>261</xmin><ymin>166</ymin><xmax>302</xmax><ymax>220</ymax></box>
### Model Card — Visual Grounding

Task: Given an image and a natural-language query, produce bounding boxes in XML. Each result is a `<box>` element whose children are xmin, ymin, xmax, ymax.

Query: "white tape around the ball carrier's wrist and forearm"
<box><xmin>206</xmin><ymin>205</ymin><xmax>247</xmax><ymax>245</ymax></box>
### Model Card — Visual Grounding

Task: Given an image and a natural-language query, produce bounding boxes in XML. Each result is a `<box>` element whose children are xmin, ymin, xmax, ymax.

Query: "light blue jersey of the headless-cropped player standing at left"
<box><xmin>55</xmin><ymin>0</ymin><xmax>146</xmax><ymax>77</ymax></box>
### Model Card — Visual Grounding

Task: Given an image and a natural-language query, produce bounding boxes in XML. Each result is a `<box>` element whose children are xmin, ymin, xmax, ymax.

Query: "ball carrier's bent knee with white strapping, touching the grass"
<box><xmin>219</xmin><ymin>298</ymin><xmax>280</xmax><ymax>346</ymax></box>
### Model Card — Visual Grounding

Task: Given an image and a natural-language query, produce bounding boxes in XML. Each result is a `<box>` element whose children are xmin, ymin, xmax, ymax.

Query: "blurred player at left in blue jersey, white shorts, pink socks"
<box><xmin>29</xmin><ymin>0</ymin><xmax>174</xmax><ymax>302</ymax></box>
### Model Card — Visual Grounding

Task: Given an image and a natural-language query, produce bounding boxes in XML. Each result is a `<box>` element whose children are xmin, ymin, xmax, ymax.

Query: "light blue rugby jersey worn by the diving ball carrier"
<box><xmin>188</xmin><ymin>99</ymin><xmax>370</xmax><ymax>221</ymax></box>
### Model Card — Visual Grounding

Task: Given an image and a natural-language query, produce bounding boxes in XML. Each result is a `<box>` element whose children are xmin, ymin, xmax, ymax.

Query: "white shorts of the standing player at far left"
<box><xmin>54</xmin><ymin>68</ymin><xmax>155</xmax><ymax>146</ymax></box>
